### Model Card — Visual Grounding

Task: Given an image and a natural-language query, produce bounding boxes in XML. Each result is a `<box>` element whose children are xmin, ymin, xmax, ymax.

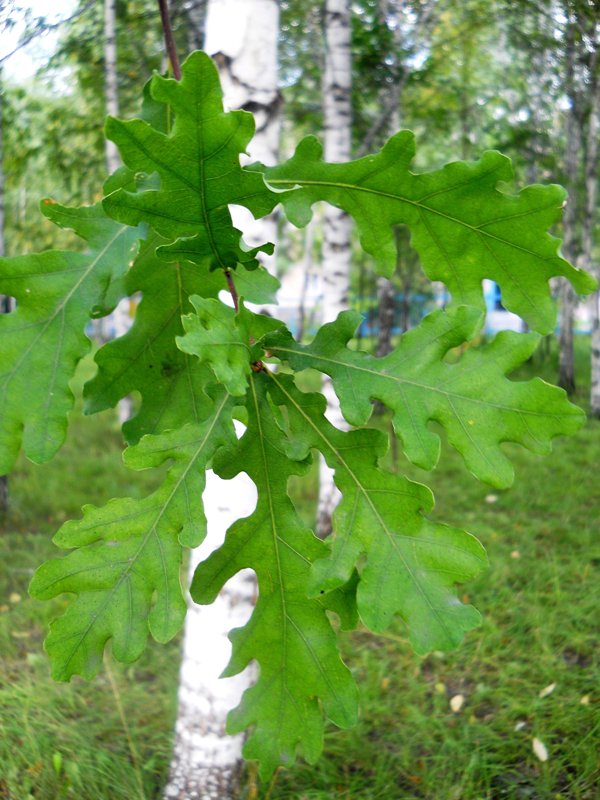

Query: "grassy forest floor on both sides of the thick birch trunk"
<box><xmin>0</xmin><ymin>340</ymin><xmax>600</xmax><ymax>800</ymax></box>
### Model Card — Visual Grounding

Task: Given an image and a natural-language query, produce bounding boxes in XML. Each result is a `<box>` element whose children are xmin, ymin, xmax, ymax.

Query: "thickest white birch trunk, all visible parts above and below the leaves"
<box><xmin>166</xmin><ymin>0</ymin><xmax>280</xmax><ymax>800</ymax></box>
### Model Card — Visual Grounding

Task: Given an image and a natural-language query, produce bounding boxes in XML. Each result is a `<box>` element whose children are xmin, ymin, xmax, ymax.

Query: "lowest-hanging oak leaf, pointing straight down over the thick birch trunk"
<box><xmin>191</xmin><ymin>372</ymin><xmax>357</xmax><ymax>779</ymax></box>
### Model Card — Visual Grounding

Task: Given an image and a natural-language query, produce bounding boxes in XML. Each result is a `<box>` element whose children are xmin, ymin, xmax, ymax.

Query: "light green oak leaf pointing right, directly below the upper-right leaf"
<box><xmin>266</xmin><ymin>306</ymin><xmax>585</xmax><ymax>488</ymax></box>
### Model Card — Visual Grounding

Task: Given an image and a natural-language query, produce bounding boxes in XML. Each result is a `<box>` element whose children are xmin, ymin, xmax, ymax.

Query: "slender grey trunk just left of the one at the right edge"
<box><xmin>558</xmin><ymin>23</ymin><xmax>581</xmax><ymax>394</ymax></box>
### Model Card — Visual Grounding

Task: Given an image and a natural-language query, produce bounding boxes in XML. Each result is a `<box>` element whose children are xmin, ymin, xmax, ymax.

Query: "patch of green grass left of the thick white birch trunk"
<box><xmin>0</xmin><ymin>362</ymin><xmax>179</xmax><ymax>800</ymax></box>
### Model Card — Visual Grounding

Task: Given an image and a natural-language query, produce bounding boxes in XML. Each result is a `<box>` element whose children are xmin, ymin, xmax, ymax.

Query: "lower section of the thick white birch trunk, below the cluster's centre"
<box><xmin>165</xmin><ymin>471</ymin><xmax>256</xmax><ymax>800</ymax></box>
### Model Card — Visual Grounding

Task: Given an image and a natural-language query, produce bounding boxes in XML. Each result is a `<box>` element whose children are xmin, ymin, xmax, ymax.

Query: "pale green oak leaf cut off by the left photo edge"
<box><xmin>0</xmin><ymin>200</ymin><xmax>141</xmax><ymax>475</ymax></box>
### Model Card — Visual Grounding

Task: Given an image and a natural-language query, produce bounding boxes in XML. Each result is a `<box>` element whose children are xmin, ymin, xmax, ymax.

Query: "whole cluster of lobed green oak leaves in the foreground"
<box><xmin>0</xmin><ymin>53</ymin><xmax>594</xmax><ymax>777</ymax></box>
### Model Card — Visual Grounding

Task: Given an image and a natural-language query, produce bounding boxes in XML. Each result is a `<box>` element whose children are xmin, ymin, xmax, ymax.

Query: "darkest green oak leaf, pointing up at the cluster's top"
<box><xmin>104</xmin><ymin>52</ymin><xmax>278</xmax><ymax>268</ymax></box>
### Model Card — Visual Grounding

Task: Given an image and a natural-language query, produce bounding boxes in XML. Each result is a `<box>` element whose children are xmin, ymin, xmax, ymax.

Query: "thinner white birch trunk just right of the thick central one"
<box><xmin>317</xmin><ymin>0</ymin><xmax>352</xmax><ymax>536</ymax></box>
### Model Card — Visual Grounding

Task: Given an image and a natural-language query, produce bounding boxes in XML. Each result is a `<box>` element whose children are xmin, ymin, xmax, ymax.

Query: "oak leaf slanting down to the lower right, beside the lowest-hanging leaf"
<box><xmin>269</xmin><ymin>373</ymin><xmax>487</xmax><ymax>654</ymax></box>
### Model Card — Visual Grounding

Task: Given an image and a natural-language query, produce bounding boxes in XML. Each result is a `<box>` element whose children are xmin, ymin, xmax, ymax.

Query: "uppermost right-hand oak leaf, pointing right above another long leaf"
<box><xmin>260</xmin><ymin>131</ymin><xmax>596</xmax><ymax>333</ymax></box>
